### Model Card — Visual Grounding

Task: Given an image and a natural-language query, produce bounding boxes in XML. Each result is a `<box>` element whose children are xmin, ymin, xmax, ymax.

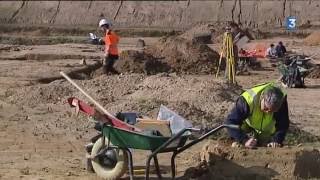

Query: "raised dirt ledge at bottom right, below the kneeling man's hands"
<box><xmin>186</xmin><ymin>141</ymin><xmax>320</xmax><ymax>180</ymax></box>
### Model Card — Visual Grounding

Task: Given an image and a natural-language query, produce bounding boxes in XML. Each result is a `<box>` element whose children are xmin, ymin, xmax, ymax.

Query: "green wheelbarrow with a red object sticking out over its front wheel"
<box><xmin>68</xmin><ymin>98</ymin><xmax>238</xmax><ymax>180</ymax></box>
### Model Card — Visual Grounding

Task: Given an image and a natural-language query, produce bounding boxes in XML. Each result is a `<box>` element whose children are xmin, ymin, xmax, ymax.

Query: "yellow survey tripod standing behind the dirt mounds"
<box><xmin>216</xmin><ymin>29</ymin><xmax>236</xmax><ymax>84</ymax></box>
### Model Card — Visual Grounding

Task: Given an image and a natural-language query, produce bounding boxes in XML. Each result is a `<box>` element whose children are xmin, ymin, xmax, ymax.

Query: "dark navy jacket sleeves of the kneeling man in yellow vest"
<box><xmin>225</xmin><ymin>96</ymin><xmax>289</xmax><ymax>144</ymax></box>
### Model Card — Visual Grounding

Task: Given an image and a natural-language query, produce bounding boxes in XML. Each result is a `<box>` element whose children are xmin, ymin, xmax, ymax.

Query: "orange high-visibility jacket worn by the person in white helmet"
<box><xmin>104</xmin><ymin>31</ymin><xmax>120</xmax><ymax>55</ymax></box>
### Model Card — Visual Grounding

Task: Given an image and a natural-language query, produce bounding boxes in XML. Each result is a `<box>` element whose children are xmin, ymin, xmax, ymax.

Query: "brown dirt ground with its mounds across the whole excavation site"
<box><xmin>0</xmin><ymin>26</ymin><xmax>320</xmax><ymax>180</ymax></box>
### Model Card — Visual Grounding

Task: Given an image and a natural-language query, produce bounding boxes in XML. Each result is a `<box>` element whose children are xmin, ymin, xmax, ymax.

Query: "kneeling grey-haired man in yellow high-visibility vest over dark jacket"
<box><xmin>225</xmin><ymin>83</ymin><xmax>289</xmax><ymax>148</ymax></box>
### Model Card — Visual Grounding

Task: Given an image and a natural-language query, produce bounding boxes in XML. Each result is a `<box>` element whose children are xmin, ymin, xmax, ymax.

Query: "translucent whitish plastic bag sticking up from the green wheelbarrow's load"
<box><xmin>157</xmin><ymin>105</ymin><xmax>192</xmax><ymax>135</ymax></box>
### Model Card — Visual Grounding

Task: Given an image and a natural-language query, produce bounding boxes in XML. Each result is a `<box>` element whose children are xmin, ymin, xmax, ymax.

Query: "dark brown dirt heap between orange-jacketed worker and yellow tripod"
<box><xmin>115</xmin><ymin>36</ymin><xmax>219</xmax><ymax>74</ymax></box>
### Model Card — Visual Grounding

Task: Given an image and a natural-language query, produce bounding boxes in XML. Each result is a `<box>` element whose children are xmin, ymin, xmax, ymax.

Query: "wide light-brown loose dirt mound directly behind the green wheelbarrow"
<box><xmin>14</xmin><ymin>73</ymin><xmax>241</xmax><ymax>126</ymax></box>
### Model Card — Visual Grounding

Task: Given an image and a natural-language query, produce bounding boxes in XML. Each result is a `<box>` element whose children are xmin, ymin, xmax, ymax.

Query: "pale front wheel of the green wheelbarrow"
<box><xmin>91</xmin><ymin>137</ymin><xmax>128</xmax><ymax>180</ymax></box>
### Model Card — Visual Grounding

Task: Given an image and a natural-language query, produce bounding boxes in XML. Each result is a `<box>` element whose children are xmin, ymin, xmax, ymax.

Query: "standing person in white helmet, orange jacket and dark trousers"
<box><xmin>99</xmin><ymin>19</ymin><xmax>119</xmax><ymax>74</ymax></box>
